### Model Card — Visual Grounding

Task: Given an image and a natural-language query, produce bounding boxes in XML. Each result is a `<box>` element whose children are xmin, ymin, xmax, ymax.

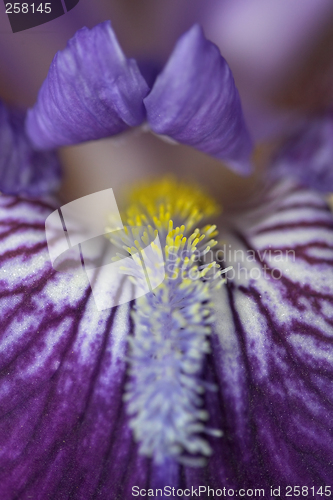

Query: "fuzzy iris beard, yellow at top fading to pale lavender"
<box><xmin>105</xmin><ymin>177</ymin><xmax>224</xmax><ymax>466</ymax></box>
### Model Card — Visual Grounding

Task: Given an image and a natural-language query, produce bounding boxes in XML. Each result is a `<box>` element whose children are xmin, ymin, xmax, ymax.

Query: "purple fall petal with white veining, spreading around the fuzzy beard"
<box><xmin>0</xmin><ymin>185</ymin><xmax>333</xmax><ymax>500</ymax></box>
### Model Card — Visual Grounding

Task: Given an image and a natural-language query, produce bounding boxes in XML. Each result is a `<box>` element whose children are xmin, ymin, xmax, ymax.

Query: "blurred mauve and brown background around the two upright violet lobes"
<box><xmin>0</xmin><ymin>0</ymin><xmax>333</xmax><ymax>207</ymax></box>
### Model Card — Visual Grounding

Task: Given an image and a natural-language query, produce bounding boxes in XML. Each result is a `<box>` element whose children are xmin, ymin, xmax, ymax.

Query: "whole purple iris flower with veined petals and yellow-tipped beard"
<box><xmin>0</xmin><ymin>19</ymin><xmax>333</xmax><ymax>500</ymax></box>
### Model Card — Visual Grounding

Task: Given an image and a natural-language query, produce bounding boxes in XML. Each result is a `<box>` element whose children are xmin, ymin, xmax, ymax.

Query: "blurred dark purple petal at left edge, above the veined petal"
<box><xmin>0</xmin><ymin>102</ymin><xmax>61</xmax><ymax>196</ymax></box>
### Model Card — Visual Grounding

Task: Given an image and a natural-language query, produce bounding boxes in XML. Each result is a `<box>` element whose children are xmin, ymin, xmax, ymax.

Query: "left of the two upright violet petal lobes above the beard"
<box><xmin>27</xmin><ymin>21</ymin><xmax>148</xmax><ymax>149</ymax></box>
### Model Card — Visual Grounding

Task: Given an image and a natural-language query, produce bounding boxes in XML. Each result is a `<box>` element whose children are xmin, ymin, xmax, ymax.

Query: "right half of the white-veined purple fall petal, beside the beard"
<box><xmin>200</xmin><ymin>184</ymin><xmax>333</xmax><ymax>490</ymax></box>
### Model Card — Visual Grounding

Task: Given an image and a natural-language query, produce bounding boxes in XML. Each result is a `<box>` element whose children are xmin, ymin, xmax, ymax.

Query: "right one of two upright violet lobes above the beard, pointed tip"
<box><xmin>144</xmin><ymin>25</ymin><xmax>252</xmax><ymax>174</ymax></box>
